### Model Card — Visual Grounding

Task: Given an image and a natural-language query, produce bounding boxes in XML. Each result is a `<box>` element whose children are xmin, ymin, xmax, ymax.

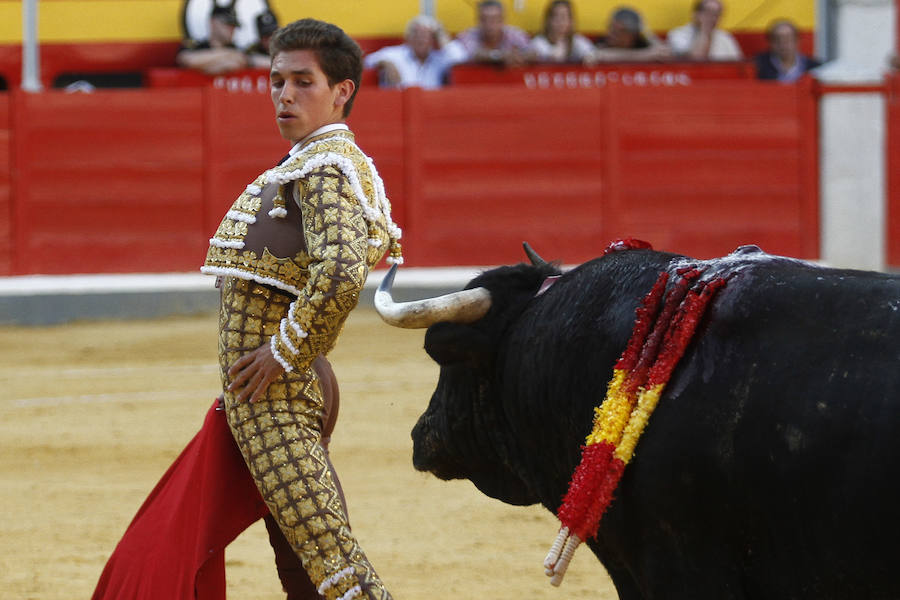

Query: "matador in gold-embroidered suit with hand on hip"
<box><xmin>201</xmin><ymin>19</ymin><xmax>402</xmax><ymax>600</ymax></box>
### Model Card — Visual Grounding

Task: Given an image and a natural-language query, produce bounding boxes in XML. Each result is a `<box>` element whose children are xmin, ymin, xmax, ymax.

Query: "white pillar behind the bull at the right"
<box><xmin>816</xmin><ymin>0</ymin><xmax>896</xmax><ymax>270</ymax></box>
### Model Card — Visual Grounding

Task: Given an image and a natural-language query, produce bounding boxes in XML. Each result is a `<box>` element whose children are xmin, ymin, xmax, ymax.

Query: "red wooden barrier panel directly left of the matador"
<box><xmin>13</xmin><ymin>89</ymin><xmax>205</xmax><ymax>274</ymax></box>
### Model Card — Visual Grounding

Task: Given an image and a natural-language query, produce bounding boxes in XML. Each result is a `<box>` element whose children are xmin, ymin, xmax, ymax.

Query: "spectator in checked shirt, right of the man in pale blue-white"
<box><xmin>451</xmin><ymin>0</ymin><xmax>533</xmax><ymax>66</ymax></box>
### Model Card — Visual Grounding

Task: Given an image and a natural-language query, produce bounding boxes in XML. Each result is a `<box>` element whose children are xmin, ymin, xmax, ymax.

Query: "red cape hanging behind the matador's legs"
<box><xmin>92</xmin><ymin>402</ymin><xmax>268</xmax><ymax>600</ymax></box>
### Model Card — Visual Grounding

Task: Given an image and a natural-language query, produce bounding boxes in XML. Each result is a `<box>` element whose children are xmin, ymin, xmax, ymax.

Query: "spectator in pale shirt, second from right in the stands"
<box><xmin>666</xmin><ymin>0</ymin><xmax>744</xmax><ymax>60</ymax></box>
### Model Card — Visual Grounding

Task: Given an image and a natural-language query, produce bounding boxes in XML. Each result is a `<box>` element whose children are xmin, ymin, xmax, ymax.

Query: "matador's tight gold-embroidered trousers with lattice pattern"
<box><xmin>219</xmin><ymin>277</ymin><xmax>391</xmax><ymax>600</ymax></box>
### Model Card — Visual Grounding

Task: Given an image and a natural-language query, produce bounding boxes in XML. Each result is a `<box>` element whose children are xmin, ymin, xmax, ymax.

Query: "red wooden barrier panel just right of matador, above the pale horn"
<box><xmin>406</xmin><ymin>87</ymin><xmax>610</xmax><ymax>265</ymax></box>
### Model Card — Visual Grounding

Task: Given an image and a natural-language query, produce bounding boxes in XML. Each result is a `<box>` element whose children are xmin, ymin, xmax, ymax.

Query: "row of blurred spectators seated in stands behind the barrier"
<box><xmin>176</xmin><ymin>0</ymin><xmax>820</xmax><ymax>89</ymax></box>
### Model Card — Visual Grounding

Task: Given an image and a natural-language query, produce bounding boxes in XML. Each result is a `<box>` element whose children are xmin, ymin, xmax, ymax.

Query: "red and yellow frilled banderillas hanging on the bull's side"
<box><xmin>544</xmin><ymin>245</ymin><xmax>725</xmax><ymax>585</ymax></box>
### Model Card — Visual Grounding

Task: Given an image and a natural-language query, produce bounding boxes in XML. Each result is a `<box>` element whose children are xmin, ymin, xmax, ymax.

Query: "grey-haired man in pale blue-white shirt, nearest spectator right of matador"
<box><xmin>363</xmin><ymin>15</ymin><xmax>455</xmax><ymax>90</ymax></box>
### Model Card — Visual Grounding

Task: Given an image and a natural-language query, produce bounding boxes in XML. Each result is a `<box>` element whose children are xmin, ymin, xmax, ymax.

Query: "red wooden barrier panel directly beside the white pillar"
<box><xmin>605</xmin><ymin>81</ymin><xmax>819</xmax><ymax>258</ymax></box>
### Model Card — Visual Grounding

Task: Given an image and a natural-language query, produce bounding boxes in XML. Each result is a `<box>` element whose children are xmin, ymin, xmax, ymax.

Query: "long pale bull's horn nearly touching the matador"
<box><xmin>375</xmin><ymin>264</ymin><xmax>491</xmax><ymax>329</ymax></box>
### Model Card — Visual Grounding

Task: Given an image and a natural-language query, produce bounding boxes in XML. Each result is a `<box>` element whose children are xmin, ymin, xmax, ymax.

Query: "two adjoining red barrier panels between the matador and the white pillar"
<box><xmin>398</xmin><ymin>82</ymin><xmax>818</xmax><ymax>265</ymax></box>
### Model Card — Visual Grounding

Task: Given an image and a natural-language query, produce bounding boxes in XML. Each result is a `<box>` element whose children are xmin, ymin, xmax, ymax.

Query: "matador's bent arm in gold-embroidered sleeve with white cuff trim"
<box><xmin>271</xmin><ymin>166</ymin><xmax>368</xmax><ymax>371</ymax></box>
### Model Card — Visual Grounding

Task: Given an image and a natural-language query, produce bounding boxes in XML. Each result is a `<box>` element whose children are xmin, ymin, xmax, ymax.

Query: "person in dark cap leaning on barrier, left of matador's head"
<box><xmin>175</xmin><ymin>6</ymin><xmax>250</xmax><ymax>75</ymax></box>
